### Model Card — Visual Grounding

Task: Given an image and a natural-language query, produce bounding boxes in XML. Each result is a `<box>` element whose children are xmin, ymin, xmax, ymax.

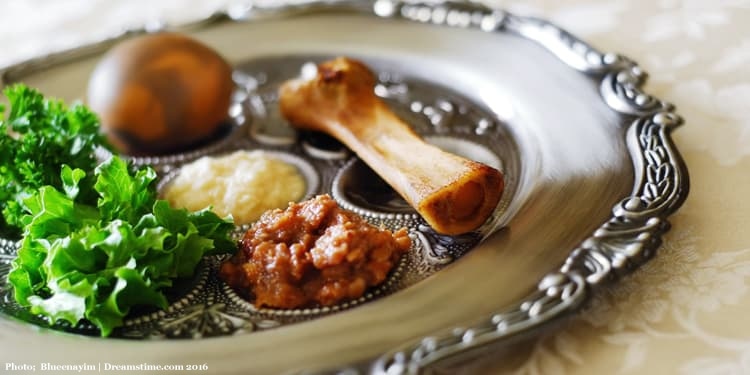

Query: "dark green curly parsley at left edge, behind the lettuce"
<box><xmin>0</xmin><ymin>84</ymin><xmax>109</xmax><ymax>238</ymax></box>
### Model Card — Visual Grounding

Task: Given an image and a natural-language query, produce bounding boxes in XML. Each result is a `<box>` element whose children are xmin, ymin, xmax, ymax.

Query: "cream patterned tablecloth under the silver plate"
<box><xmin>0</xmin><ymin>0</ymin><xmax>750</xmax><ymax>374</ymax></box>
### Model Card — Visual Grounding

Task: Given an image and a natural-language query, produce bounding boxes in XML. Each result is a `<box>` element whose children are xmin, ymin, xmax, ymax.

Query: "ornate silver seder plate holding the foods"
<box><xmin>0</xmin><ymin>0</ymin><xmax>688</xmax><ymax>373</ymax></box>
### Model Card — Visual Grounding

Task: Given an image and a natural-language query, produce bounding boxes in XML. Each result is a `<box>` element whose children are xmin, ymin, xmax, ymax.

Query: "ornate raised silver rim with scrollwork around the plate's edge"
<box><xmin>0</xmin><ymin>0</ymin><xmax>690</xmax><ymax>374</ymax></box>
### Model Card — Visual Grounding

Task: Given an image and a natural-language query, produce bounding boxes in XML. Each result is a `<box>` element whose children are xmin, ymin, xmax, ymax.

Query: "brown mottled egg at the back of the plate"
<box><xmin>87</xmin><ymin>33</ymin><xmax>234</xmax><ymax>155</ymax></box>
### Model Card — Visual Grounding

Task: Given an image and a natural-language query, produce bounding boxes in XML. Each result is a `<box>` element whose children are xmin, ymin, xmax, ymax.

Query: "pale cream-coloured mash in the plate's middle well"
<box><xmin>164</xmin><ymin>150</ymin><xmax>305</xmax><ymax>224</ymax></box>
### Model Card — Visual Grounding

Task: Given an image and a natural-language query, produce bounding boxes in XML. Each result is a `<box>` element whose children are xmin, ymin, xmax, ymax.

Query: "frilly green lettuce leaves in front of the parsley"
<box><xmin>8</xmin><ymin>156</ymin><xmax>236</xmax><ymax>336</ymax></box>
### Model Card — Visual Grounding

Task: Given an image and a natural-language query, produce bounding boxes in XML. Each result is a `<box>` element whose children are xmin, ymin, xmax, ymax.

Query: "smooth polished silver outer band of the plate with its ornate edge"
<box><xmin>0</xmin><ymin>0</ymin><xmax>688</xmax><ymax>374</ymax></box>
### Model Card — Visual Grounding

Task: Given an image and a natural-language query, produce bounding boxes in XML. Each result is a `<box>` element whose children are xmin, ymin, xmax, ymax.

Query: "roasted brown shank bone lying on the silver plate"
<box><xmin>280</xmin><ymin>57</ymin><xmax>504</xmax><ymax>235</ymax></box>
